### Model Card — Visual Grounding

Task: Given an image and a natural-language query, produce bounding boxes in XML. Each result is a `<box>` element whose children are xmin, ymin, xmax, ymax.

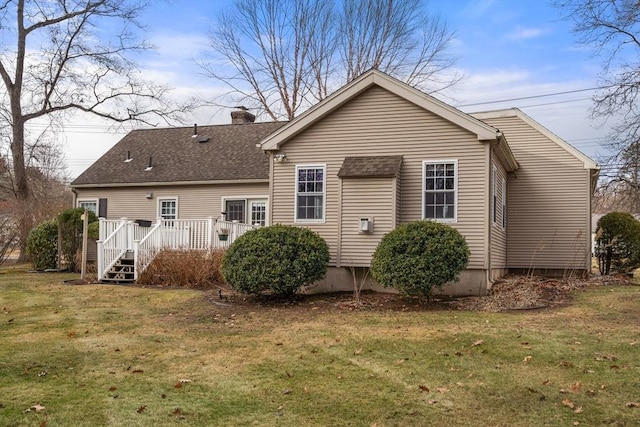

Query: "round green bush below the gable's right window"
<box><xmin>371</xmin><ymin>221</ymin><xmax>469</xmax><ymax>297</ymax></box>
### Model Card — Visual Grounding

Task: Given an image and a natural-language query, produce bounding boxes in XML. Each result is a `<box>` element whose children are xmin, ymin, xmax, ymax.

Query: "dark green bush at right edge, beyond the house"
<box><xmin>596</xmin><ymin>212</ymin><xmax>640</xmax><ymax>274</ymax></box>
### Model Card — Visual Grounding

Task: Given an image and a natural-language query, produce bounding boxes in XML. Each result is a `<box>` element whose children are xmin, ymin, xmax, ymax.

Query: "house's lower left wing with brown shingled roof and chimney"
<box><xmin>71</xmin><ymin>110</ymin><xmax>285</xmax><ymax>225</ymax></box>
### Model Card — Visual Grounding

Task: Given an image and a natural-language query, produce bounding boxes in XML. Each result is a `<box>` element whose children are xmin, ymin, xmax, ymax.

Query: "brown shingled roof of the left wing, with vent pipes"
<box><xmin>71</xmin><ymin>122</ymin><xmax>286</xmax><ymax>186</ymax></box>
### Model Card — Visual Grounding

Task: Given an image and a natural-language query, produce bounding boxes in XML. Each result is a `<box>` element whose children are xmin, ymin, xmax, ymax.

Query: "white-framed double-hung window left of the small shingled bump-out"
<box><xmin>295</xmin><ymin>165</ymin><xmax>326</xmax><ymax>222</ymax></box>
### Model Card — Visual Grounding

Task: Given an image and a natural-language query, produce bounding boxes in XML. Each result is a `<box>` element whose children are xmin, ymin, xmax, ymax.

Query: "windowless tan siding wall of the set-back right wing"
<box><xmin>484</xmin><ymin>117</ymin><xmax>590</xmax><ymax>270</ymax></box>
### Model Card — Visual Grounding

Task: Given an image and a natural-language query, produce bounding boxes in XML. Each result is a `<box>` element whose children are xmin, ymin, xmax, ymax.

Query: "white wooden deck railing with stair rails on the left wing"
<box><xmin>98</xmin><ymin>218</ymin><xmax>256</xmax><ymax>279</ymax></box>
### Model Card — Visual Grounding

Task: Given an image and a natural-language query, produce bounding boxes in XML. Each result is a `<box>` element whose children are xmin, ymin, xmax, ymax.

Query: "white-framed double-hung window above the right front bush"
<box><xmin>422</xmin><ymin>160</ymin><xmax>458</xmax><ymax>222</ymax></box>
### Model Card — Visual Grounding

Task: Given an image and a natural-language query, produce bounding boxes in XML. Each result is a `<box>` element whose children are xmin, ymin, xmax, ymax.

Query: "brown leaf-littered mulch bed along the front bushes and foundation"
<box><xmin>202</xmin><ymin>276</ymin><xmax>630</xmax><ymax>317</ymax></box>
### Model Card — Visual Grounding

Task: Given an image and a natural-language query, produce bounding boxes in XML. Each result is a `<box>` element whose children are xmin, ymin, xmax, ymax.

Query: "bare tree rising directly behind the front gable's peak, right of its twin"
<box><xmin>337</xmin><ymin>0</ymin><xmax>457</xmax><ymax>91</ymax></box>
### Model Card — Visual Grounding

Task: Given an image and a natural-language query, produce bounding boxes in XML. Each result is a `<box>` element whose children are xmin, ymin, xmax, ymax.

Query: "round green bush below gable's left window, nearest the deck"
<box><xmin>222</xmin><ymin>225</ymin><xmax>329</xmax><ymax>296</ymax></box>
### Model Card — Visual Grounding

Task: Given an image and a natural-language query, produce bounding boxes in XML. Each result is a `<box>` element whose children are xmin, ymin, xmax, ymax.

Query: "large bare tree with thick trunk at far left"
<box><xmin>0</xmin><ymin>0</ymin><xmax>188</xmax><ymax>258</ymax></box>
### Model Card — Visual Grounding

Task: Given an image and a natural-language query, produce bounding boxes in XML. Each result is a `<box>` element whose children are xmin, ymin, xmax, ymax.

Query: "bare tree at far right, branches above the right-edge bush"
<box><xmin>555</xmin><ymin>0</ymin><xmax>640</xmax><ymax>213</ymax></box>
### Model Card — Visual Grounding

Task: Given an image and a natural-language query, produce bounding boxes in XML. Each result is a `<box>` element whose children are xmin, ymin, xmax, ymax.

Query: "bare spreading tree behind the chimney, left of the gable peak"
<box><xmin>201</xmin><ymin>0</ymin><xmax>333</xmax><ymax>120</ymax></box>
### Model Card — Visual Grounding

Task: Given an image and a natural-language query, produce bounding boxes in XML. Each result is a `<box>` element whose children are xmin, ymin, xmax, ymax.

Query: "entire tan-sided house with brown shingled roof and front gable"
<box><xmin>72</xmin><ymin>70</ymin><xmax>598</xmax><ymax>295</ymax></box>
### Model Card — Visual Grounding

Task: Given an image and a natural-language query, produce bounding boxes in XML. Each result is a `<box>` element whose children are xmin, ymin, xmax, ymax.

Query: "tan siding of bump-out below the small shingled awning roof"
<box><xmin>340</xmin><ymin>178</ymin><xmax>395</xmax><ymax>267</ymax></box>
